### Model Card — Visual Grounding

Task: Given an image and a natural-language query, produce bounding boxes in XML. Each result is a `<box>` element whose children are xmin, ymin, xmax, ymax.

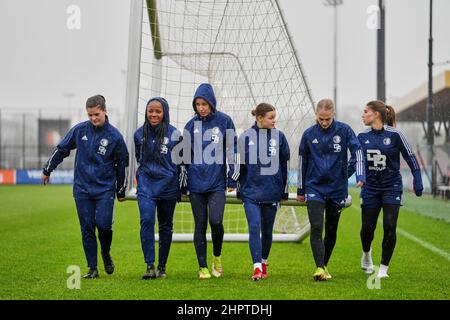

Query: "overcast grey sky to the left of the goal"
<box><xmin>0</xmin><ymin>0</ymin><xmax>129</xmax><ymax>112</ymax></box>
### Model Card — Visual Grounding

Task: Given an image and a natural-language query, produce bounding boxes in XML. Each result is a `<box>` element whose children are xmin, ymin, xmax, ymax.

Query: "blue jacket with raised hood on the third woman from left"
<box><xmin>183</xmin><ymin>83</ymin><xmax>239</xmax><ymax>193</ymax></box>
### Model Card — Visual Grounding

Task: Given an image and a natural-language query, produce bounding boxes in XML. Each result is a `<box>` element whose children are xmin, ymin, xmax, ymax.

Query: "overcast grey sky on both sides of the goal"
<box><xmin>0</xmin><ymin>0</ymin><xmax>450</xmax><ymax>124</ymax></box>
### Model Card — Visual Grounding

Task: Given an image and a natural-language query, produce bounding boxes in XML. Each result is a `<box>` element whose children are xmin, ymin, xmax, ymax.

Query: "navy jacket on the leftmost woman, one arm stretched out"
<box><xmin>43</xmin><ymin>117</ymin><xmax>129</xmax><ymax>199</ymax></box>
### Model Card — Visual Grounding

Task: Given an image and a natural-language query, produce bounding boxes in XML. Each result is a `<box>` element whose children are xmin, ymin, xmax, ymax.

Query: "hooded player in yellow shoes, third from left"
<box><xmin>183</xmin><ymin>83</ymin><xmax>239</xmax><ymax>279</ymax></box>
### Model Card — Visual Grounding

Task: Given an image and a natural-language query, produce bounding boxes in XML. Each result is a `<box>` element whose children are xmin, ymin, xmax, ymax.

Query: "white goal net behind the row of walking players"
<box><xmin>122</xmin><ymin>0</ymin><xmax>314</xmax><ymax>241</ymax></box>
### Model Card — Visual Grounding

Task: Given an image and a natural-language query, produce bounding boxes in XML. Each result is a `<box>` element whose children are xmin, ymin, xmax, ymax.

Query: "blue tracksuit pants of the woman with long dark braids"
<box><xmin>138</xmin><ymin>195</ymin><xmax>177</xmax><ymax>268</ymax></box>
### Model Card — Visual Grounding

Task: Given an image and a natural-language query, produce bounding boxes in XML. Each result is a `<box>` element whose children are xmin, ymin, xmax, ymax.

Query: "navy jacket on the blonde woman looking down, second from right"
<box><xmin>297</xmin><ymin>121</ymin><xmax>365</xmax><ymax>201</ymax></box>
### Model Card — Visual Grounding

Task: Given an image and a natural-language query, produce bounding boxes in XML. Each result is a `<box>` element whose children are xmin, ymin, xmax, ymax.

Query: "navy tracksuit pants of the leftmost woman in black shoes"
<box><xmin>75</xmin><ymin>198</ymin><xmax>114</xmax><ymax>269</ymax></box>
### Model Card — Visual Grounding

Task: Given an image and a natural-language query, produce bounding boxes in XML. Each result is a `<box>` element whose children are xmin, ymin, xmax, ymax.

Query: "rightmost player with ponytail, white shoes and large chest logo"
<box><xmin>350</xmin><ymin>101</ymin><xmax>423</xmax><ymax>278</ymax></box>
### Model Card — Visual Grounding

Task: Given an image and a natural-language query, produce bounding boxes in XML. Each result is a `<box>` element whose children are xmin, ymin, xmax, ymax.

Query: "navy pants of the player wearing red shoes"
<box><xmin>244</xmin><ymin>201</ymin><xmax>278</xmax><ymax>263</ymax></box>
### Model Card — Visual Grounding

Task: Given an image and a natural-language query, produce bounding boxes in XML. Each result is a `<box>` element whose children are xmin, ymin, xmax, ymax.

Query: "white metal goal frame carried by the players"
<box><xmin>125</xmin><ymin>0</ymin><xmax>320</xmax><ymax>242</ymax></box>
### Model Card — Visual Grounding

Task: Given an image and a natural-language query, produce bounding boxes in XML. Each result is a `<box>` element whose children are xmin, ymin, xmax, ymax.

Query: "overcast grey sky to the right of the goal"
<box><xmin>280</xmin><ymin>0</ymin><xmax>450</xmax><ymax>110</ymax></box>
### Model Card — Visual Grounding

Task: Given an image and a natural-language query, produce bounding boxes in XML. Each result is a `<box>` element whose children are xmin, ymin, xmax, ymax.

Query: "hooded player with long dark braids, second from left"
<box><xmin>134</xmin><ymin>97</ymin><xmax>181</xmax><ymax>279</ymax></box>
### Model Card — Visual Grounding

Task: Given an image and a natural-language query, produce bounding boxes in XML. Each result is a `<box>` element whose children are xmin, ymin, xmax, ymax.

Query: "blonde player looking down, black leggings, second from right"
<box><xmin>297</xmin><ymin>99</ymin><xmax>365</xmax><ymax>281</ymax></box>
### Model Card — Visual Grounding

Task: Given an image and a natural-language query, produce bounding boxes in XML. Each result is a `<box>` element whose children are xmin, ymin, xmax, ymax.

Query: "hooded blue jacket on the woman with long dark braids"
<box><xmin>134</xmin><ymin>98</ymin><xmax>181</xmax><ymax>200</ymax></box>
